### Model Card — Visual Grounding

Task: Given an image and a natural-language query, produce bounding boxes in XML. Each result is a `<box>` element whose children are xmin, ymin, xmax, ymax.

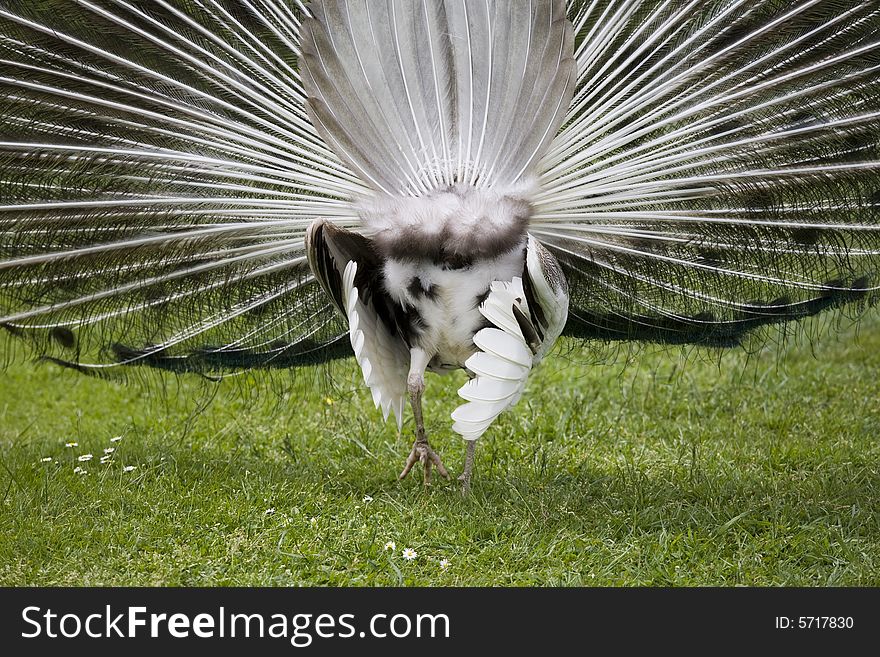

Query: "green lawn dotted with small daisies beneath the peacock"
<box><xmin>0</xmin><ymin>319</ymin><xmax>880</xmax><ymax>586</ymax></box>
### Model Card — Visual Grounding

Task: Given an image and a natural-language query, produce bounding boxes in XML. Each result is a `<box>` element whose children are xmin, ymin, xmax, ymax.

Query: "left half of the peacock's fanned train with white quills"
<box><xmin>0</xmin><ymin>1</ymin><xmax>365</xmax><ymax>372</ymax></box>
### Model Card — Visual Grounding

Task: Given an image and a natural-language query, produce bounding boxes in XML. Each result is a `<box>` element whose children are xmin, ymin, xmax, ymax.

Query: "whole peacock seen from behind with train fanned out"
<box><xmin>0</xmin><ymin>0</ymin><xmax>880</xmax><ymax>490</ymax></box>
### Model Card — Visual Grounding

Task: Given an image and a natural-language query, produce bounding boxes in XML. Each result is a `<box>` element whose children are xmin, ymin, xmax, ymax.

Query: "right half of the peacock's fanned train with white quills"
<box><xmin>530</xmin><ymin>0</ymin><xmax>880</xmax><ymax>345</ymax></box>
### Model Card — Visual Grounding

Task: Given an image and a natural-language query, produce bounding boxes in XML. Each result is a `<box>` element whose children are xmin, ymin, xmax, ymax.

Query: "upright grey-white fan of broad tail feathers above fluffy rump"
<box><xmin>302</xmin><ymin>0</ymin><xmax>576</xmax><ymax>196</ymax></box>
